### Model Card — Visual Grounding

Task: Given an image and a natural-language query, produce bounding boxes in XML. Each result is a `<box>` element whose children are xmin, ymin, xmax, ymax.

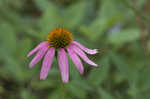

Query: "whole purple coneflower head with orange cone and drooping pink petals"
<box><xmin>27</xmin><ymin>28</ymin><xmax>98</xmax><ymax>83</ymax></box>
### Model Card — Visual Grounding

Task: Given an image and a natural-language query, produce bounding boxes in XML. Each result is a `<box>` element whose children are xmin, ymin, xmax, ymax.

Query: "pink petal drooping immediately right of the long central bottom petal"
<box><xmin>67</xmin><ymin>46</ymin><xmax>84</xmax><ymax>74</ymax></box>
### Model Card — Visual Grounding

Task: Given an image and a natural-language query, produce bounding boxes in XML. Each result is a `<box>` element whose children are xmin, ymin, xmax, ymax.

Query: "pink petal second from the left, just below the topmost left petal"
<box><xmin>29</xmin><ymin>46</ymin><xmax>49</xmax><ymax>68</ymax></box>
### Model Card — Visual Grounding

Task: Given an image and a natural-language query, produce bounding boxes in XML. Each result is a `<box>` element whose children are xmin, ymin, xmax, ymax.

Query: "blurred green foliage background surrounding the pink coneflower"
<box><xmin>0</xmin><ymin>0</ymin><xmax>150</xmax><ymax>99</ymax></box>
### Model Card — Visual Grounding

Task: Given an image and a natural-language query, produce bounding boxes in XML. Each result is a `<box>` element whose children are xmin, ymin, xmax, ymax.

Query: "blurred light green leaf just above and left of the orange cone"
<box><xmin>39</xmin><ymin>3</ymin><xmax>63</xmax><ymax>38</ymax></box>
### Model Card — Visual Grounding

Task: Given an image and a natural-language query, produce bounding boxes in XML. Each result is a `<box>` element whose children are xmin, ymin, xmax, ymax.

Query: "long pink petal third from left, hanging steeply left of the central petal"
<box><xmin>40</xmin><ymin>47</ymin><xmax>55</xmax><ymax>80</ymax></box>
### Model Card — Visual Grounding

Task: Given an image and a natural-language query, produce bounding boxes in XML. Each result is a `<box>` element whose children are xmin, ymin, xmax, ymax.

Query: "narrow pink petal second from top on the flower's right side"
<box><xmin>72</xmin><ymin>45</ymin><xmax>97</xmax><ymax>66</ymax></box>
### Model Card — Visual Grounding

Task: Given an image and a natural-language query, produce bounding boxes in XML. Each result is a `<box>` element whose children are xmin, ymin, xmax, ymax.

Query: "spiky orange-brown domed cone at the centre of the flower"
<box><xmin>46</xmin><ymin>28</ymin><xmax>73</xmax><ymax>48</ymax></box>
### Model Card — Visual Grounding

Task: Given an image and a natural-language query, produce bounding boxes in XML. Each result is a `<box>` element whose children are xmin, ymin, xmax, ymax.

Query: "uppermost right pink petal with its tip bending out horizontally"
<box><xmin>73</xmin><ymin>41</ymin><xmax>98</xmax><ymax>54</ymax></box>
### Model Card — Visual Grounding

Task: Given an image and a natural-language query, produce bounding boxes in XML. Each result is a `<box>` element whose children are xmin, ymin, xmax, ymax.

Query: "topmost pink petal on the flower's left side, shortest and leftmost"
<box><xmin>27</xmin><ymin>41</ymin><xmax>48</xmax><ymax>57</ymax></box>
